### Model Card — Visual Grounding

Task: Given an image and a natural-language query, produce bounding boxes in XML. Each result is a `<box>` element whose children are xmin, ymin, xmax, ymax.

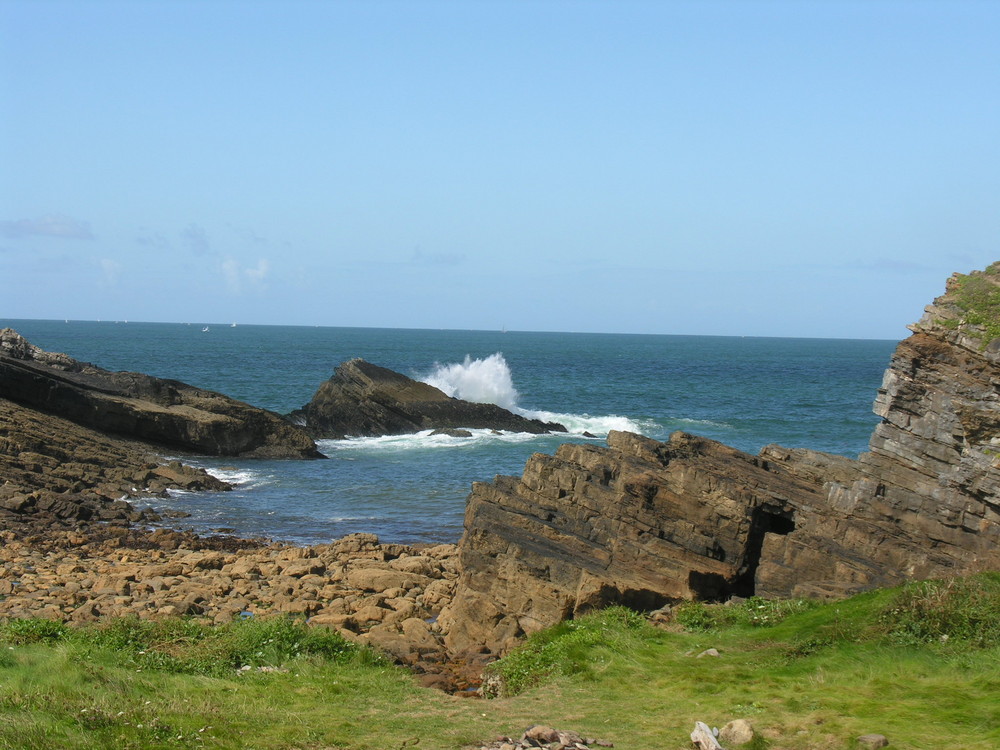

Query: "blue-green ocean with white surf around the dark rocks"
<box><xmin>0</xmin><ymin>320</ymin><xmax>897</xmax><ymax>544</ymax></box>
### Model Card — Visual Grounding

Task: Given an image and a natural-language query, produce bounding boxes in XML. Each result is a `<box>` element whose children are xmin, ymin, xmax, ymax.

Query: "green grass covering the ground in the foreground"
<box><xmin>0</xmin><ymin>574</ymin><xmax>1000</xmax><ymax>750</ymax></box>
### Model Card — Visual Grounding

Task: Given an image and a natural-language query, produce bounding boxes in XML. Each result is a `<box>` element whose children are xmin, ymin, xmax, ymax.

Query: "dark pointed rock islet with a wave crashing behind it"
<box><xmin>293</xmin><ymin>359</ymin><xmax>566</xmax><ymax>439</ymax></box>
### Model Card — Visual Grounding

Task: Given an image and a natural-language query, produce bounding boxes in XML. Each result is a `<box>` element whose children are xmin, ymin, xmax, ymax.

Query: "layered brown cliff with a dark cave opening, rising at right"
<box><xmin>440</xmin><ymin>267</ymin><xmax>1000</xmax><ymax>653</ymax></box>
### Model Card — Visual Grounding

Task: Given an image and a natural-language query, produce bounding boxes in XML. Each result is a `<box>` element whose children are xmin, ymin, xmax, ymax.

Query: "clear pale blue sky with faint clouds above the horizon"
<box><xmin>0</xmin><ymin>0</ymin><xmax>1000</xmax><ymax>339</ymax></box>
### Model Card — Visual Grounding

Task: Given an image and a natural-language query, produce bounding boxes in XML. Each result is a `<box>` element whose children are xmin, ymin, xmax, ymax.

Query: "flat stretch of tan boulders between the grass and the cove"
<box><xmin>0</xmin><ymin>524</ymin><xmax>477</xmax><ymax>691</ymax></box>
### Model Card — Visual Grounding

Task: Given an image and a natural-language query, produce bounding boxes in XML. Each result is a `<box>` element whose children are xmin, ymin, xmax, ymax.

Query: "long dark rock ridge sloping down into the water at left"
<box><xmin>0</xmin><ymin>328</ymin><xmax>322</xmax><ymax>458</ymax></box>
